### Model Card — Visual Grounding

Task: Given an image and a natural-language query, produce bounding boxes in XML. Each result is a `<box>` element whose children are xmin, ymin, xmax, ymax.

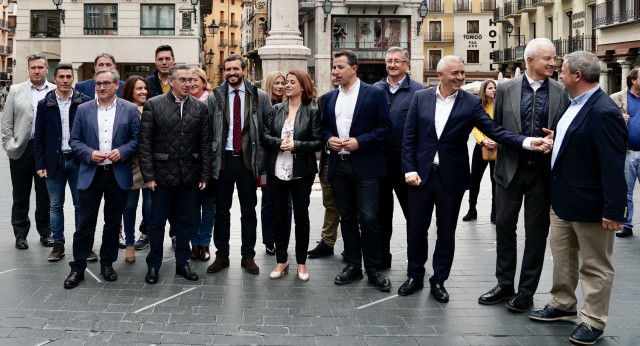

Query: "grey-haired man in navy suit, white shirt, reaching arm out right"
<box><xmin>398</xmin><ymin>55</ymin><xmax>552</xmax><ymax>303</ymax></box>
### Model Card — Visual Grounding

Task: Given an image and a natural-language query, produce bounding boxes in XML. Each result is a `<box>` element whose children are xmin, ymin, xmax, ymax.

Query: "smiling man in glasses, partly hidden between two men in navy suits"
<box><xmin>374</xmin><ymin>47</ymin><xmax>424</xmax><ymax>269</ymax></box>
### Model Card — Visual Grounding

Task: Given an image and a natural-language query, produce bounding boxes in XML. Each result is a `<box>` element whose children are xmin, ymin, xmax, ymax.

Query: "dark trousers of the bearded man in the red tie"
<box><xmin>213</xmin><ymin>152</ymin><xmax>258</xmax><ymax>258</ymax></box>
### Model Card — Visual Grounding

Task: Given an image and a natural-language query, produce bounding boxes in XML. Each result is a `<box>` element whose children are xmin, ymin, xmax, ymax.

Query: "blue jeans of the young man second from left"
<box><xmin>45</xmin><ymin>156</ymin><xmax>80</xmax><ymax>245</ymax></box>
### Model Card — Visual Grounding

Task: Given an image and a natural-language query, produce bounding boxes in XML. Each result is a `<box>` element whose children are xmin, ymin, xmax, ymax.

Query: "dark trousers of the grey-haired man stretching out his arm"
<box><xmin>407</xmin><ymin>170</ymin><xmax>464</xmax><ymax>284</ymax></box>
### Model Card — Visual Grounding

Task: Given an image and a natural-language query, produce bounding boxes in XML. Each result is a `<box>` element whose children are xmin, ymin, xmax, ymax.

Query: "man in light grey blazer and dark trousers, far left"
<box><xmin>1</xmin><ymin>53</ymin><xmax>55</xmax><ymax>250</ymax></box>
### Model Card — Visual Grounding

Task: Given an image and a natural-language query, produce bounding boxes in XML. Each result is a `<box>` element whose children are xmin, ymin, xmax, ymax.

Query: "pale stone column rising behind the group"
<box><xmin>258</xmin><ymin>0</ymin><xmax>311</xmax><ymax>84</ymax></box>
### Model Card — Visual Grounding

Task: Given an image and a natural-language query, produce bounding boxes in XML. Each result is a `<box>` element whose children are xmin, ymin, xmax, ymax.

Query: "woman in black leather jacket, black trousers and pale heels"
<box><xmin>262</xmin><ymin>70</ymin><xmax>322</xmax><ymax>281</ymax></box>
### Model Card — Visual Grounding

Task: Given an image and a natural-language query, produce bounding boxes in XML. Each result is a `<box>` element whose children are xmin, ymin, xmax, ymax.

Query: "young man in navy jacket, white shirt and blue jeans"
<box><xmin>33</xmin><ymin>64</ymin><xmax>91</xmax><ymax>262</ymax></box>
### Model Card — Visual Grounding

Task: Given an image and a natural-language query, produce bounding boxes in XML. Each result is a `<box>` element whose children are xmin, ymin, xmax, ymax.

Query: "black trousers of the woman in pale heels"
<box><xmin>267</xmin><ymin>175</ymin><xmax>315</xmax><ymax>264</ymax></box>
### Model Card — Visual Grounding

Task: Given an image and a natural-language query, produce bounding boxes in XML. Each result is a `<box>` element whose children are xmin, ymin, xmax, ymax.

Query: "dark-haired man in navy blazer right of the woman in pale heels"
<box><xmin>322</xmin><ymin>50</ymin><xmax>391</xmax><ymax>291</ymax></box>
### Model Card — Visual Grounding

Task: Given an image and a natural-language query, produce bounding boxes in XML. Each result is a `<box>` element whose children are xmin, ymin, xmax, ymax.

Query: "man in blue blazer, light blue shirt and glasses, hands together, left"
<box><xmin>64</xmin><ymin>69</ymin><xmax>140</xmax><ymax>288</ymax></box>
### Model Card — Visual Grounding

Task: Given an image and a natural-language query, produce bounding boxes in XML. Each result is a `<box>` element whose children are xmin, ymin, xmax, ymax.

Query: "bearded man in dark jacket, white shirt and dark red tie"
<box><xmin>207</xmin><ymin>54</ymin><xmax>271</xmax><ymax>274</ymax></box>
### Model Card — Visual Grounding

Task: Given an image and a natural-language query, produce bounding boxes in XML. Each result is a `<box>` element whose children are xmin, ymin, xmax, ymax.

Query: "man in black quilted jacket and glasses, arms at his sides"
<box><xmin>140</xmin><ymin>65</ymin><xmax>212</xmax><ymax>284</ymax></box>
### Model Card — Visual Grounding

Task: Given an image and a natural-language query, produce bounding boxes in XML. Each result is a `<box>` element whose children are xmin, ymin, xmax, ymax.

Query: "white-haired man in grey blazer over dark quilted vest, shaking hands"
<box><xmin>478</xmin><ymin>38</ymin><xmax>569</xmax><ymax>312</ymax></box>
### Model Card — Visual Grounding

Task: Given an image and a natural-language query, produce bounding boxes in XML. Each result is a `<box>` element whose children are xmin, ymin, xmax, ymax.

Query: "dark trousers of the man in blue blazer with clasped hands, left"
<box><xmin>69</xmin><ymin>166</ymin><xmax>129</xmax><ymax>273</ymax></box>
